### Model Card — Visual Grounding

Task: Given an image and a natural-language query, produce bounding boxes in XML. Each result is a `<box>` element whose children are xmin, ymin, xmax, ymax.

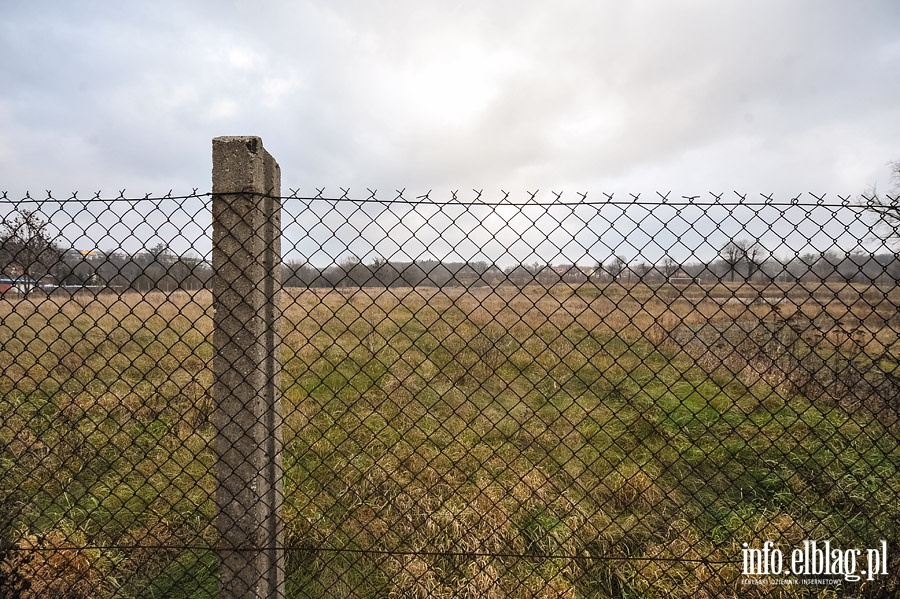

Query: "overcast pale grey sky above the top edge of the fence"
<box><xmin>0</xmin><ymin>0</ymin><xmax>900</xmax><ymax>262</ymax></box>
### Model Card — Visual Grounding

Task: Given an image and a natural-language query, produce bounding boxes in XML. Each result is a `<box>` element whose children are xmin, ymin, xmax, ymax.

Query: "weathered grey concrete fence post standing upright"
<box><xmin>212</xmin><ymin>137</ymin><xmax>284</xmax><ymax>599</ymax></box>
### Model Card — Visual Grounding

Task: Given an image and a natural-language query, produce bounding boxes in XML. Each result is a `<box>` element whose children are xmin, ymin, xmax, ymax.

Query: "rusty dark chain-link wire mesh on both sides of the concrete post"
<box><xmin>0</xmin><ymin>190</ymin><xmax>900</xmax><ymax>598</ymax></box>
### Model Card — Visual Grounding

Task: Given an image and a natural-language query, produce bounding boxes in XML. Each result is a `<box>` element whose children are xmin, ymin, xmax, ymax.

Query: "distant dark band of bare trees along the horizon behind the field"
<box><xmin>0</xmin><ymin>160</ymin><xmax>900</xmax><ymax>291</ymax></box>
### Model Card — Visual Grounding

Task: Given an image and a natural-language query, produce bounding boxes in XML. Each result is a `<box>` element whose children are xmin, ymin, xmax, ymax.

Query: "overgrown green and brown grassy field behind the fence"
<box><xmin>0</xmin><ymin>283</ymin><xmax>900</xmax><ymax>599</ymax></box>
